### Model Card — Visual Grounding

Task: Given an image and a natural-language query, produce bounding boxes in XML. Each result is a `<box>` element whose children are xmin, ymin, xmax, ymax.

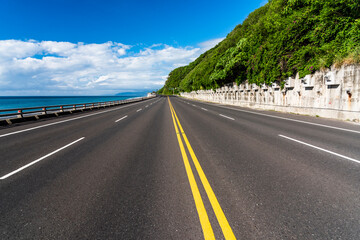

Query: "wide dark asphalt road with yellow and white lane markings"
<box><xmin>0</xmin><ymin>97</ymin><xmax>360</xmax><ymax>239</ymax></box>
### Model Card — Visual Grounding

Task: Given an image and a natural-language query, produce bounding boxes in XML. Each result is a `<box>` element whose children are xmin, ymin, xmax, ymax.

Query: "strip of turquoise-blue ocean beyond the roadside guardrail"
<box><xmin>0</xmin><ymin>94</ymin><xmax>144</xmax><ymax>110</ymax></box>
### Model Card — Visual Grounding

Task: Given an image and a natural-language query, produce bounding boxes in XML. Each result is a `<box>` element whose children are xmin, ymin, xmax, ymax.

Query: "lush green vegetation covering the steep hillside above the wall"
<box><xmin>159</xmin><ymin>0</ymin><xmax>360</xmax><ymax>94</ymax></box>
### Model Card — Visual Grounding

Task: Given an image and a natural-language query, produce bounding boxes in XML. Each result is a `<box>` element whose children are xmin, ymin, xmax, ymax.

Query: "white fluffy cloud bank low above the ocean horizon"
<box><xmin>0</xmin><ymin>40</ymin><xmax>218</xmax><ymax>96</ymax></box>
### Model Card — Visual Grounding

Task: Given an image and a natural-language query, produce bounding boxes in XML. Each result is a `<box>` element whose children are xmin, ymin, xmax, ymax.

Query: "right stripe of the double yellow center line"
<box><xmin>169</xmin><ymin>99</ymin><xmax>236</xmax><ymax>239</ymax></box>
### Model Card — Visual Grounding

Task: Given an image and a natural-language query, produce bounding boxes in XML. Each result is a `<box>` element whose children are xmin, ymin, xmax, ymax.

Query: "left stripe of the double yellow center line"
<box><xmin>168</xmin><ymin>99</ymin><xmax>215</xmax><ymax>239</ymax></box>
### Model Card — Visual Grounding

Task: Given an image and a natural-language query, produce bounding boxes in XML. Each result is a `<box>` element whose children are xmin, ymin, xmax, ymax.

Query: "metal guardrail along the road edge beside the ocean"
<box><xmin>0</xmin><ymin>96</ymin><xmax>153</xmax><ymax>120</ymax></box>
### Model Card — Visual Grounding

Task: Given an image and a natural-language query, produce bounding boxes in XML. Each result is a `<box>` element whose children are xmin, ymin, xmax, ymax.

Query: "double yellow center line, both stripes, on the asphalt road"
<box><xmin>168</xmin><ymin>98</ymin><xmax>236</xmax><ymax>239</ymax></box>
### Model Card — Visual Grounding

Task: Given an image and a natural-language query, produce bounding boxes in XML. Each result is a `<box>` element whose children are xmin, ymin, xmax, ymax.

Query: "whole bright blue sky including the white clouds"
<box><xmin>0</xmin><ymin>0</ymin><xmax>267</xmax><ymax>95</ymax></box>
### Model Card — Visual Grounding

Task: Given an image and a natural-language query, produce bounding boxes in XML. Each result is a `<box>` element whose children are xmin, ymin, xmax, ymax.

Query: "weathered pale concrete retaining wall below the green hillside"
<box><xmin>181</xmin><ymin>65</ymin><xmax>360</xmax><ymax>122</ymax></box>
